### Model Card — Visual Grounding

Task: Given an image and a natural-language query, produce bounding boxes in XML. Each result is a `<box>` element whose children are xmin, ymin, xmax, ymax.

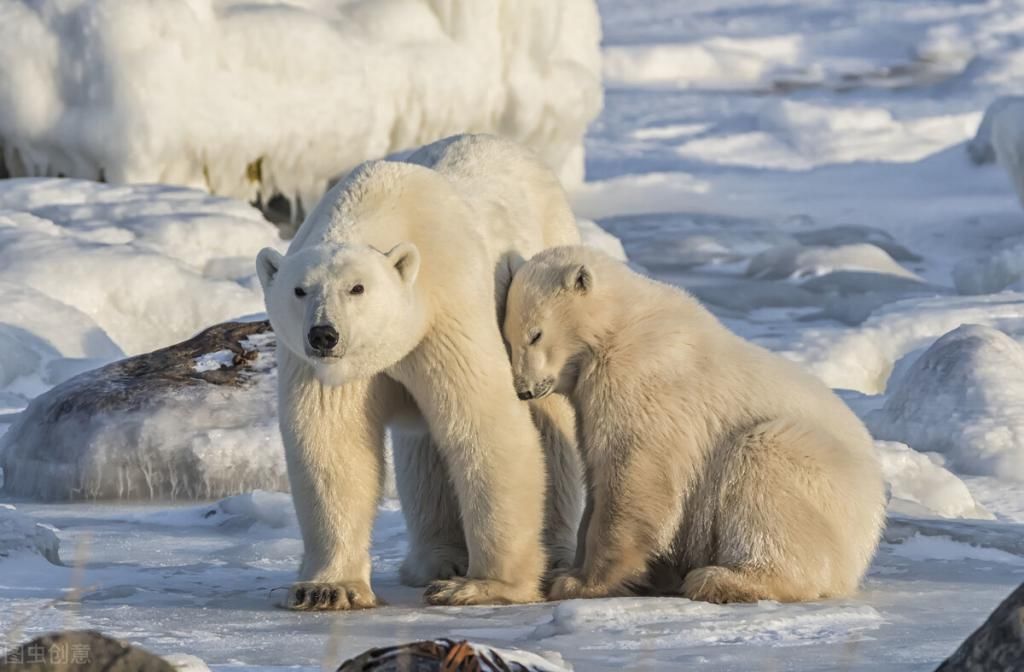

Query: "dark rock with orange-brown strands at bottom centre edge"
<box><xmin>338</xmin><ymin>639</ymin><xmax>551</xmax><ymax>672</ymax></box>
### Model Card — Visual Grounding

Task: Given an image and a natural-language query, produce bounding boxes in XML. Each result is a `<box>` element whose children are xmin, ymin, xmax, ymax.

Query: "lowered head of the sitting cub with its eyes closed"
<box><xmin>504</xmin><ymin>247</ymin><xmax>597</xmax><ymax>400</ymax></box>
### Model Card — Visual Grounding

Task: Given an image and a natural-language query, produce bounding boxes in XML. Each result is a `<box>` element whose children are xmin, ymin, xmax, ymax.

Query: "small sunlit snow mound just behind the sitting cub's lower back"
<box><xmin>874</xmin><ymin>440</ymin><xmax>993</xmax><ymax>519</ymax></box>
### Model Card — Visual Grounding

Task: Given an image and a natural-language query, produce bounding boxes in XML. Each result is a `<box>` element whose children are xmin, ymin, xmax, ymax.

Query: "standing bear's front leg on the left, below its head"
<box><xmin>278</xmin><ymin>362</ymin><xmax>393</xmax><ymax>610</ymax></box>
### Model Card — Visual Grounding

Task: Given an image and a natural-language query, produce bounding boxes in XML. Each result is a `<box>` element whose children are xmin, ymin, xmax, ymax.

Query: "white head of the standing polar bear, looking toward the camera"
<box><xmin>256</xmin><ymin>243</ymin><xmax>422</xmax><ymax>385</ymax></box>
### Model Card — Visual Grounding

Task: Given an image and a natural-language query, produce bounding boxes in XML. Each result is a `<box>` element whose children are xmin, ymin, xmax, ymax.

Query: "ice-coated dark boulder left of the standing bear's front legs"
<box><xmin>0</xmin><ymin>321</ymin><xmax>288</xmax><ymax>500</ymax></box>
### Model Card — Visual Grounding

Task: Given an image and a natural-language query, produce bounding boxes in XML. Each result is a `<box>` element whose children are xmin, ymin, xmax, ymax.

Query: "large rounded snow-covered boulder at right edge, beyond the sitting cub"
<box><xmin>867</xmin><ymin>325</ymin><xmax>1024</xmax><ymax>480</ymax></box>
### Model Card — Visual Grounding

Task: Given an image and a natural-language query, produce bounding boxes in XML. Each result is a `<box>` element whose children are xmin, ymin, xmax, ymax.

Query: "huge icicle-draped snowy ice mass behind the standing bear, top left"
<box><xmin>0</xmin><ymin>0</ymin><xmax>602</xmax><ymax>209</ymax></box>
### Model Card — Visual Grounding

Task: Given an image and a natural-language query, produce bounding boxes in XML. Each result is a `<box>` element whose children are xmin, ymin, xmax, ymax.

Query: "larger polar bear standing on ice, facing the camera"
<box><xmin>257</xmin><ymin>135</ymin><xmax>581</xmax><ymax>610</ymax></box>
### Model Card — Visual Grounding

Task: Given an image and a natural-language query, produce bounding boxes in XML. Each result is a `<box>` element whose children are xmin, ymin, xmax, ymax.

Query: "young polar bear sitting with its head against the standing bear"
<box><xmin>504</xmin><ymin>247</ymin><xmax>885</xmax><ymax>602</ymax></box>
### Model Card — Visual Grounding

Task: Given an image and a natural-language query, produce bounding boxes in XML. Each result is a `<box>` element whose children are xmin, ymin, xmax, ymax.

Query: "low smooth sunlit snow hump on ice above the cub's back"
<box><xmin>746</xmin><ymin>243</ymin><xmax>920</xmax><ymax>280</ymax></box>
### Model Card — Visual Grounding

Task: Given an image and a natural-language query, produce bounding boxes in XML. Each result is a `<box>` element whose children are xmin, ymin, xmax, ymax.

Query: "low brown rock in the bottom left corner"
<box><xmin>0</xmin><ymin>630</ymin><xmax>174</xmax><ymax>672</ymax></box>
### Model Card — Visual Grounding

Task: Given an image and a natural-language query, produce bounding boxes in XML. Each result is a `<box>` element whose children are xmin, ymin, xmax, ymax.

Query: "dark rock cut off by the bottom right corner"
<box><xmin>935</xmin><ymin>584</ymin><xmax>1024</xmax><ymax>672</ymax></box>
